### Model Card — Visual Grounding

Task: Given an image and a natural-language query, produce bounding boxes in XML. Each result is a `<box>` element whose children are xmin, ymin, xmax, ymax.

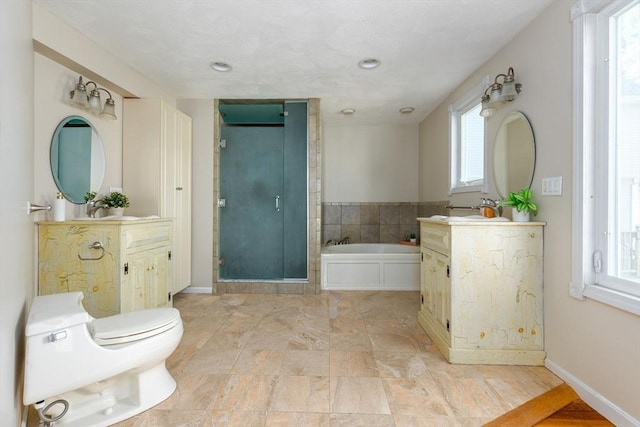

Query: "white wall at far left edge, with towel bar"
<box><xmin>0</xmin><ymin>0</ymin><xmax>34</xmax><ymax>426</ymax></box>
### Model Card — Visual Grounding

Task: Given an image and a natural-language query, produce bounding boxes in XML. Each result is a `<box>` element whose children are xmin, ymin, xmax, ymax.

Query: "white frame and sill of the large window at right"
<box><xmin>569</xmin><ymin>0</ymin><xmax>640</xmax><ymax>315</ymax></box>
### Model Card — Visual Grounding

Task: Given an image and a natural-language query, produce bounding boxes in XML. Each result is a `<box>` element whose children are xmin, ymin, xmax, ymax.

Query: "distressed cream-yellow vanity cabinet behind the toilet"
<box><xmin>38</xmin><ymin>219</ymin><xmax>173</xmax><ymax>318</ymax></box>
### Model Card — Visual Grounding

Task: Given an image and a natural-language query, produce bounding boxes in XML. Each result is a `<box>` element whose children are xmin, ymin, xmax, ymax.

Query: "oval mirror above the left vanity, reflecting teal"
<box><xmin>50</xmin><ymin>116</ymin><xmax>105</xmax><ymax>204</ymax></box>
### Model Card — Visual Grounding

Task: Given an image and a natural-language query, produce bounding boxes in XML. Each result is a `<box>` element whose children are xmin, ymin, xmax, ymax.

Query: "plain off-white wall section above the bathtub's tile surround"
<box><xmin>322</xmin><ymin>124</ymin><xmax>418</xmax><ymax>202</ymax></box>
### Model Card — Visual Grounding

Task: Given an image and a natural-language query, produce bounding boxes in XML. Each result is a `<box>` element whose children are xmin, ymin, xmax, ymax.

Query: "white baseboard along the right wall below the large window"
<box><xmin>545</xmin><ymin>358</ymin><xmax>640</xmax><ymax>427</ymax></box>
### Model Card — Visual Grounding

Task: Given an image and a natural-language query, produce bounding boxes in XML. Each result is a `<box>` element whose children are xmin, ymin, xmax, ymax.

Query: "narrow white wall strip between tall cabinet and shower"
<box><xmin>176</xmin><ymin>99</ymin><xmax>215</xmax><ymax>288</ymax></box>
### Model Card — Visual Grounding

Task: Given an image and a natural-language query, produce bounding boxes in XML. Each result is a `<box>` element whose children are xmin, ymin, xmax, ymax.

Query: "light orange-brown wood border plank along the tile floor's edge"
<box><xmin>485</xmin><ymin>383</ymin><xmax>579</xmax><ymax>427</ymax></box>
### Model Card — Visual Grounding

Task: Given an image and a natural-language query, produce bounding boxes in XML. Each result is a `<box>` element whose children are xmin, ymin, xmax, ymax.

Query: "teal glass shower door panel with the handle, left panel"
<box><xmin>219</xmin><ymin>126</ymin><xmax>284</xmax><ymax>280</ymax></box>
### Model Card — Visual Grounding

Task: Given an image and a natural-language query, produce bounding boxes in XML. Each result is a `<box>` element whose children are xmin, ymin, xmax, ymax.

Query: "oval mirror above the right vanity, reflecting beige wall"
<box><xmin>493</xmin><ymin>111</ymin><xmax>536</xmax><ymax>199</ymax></box>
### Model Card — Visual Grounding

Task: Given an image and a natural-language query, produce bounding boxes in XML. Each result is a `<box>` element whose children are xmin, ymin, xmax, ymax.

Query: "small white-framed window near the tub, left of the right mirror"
<box><xmin>449</xmin><ymin>82</ymin><xmax>485</xmax><ymax>194</ymax></box>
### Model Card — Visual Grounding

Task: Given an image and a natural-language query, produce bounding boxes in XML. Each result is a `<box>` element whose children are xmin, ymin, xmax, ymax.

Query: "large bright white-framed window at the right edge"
<box><xmin>571</xmin><ymin>0</ymin><xmax>640</xmax><ymax>314</ymax></box>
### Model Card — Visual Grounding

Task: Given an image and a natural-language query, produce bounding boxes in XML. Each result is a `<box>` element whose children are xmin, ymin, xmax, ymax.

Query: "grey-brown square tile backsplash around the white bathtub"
<box><xmin>322</xmin><ymin>200</ymin><xmax>449</xmax><ymax>243</ymax></box>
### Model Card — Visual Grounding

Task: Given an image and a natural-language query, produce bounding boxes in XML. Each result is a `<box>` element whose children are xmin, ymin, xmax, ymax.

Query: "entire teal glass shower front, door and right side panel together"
<box><xmin>219</xmin><ymin>102</ymin><xmax>308</xmax><ymax>281</ymax></box>
